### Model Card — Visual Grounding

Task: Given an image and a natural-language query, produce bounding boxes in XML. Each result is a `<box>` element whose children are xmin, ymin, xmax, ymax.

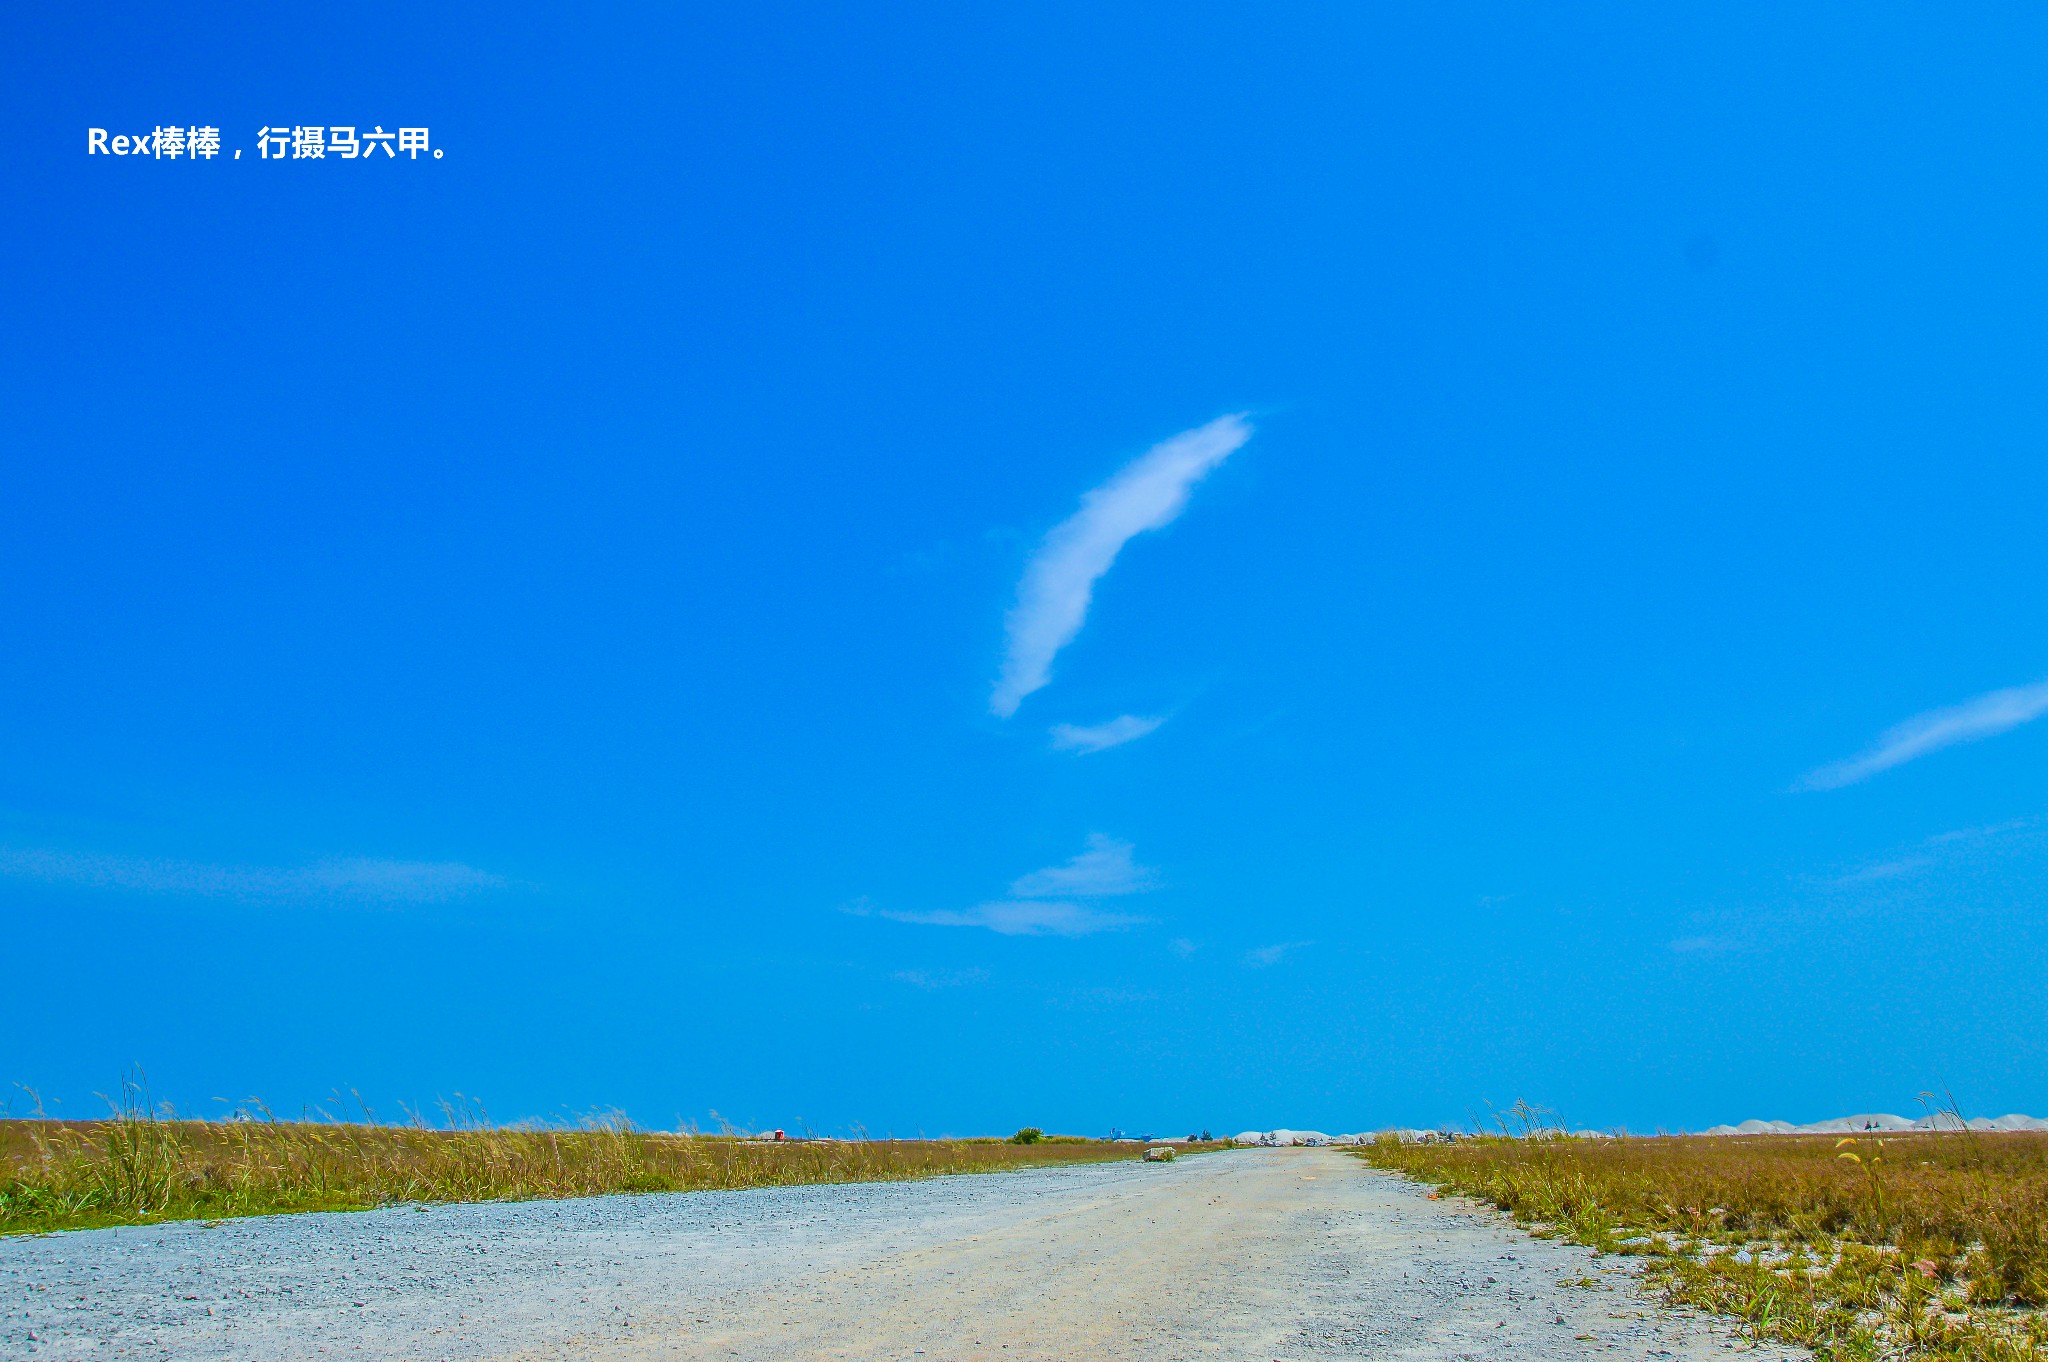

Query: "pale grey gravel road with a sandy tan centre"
<box><xmin>0</xmin><ymin>1149</ymin><xmax>1804</xmax><ymax>1362</ymax></box>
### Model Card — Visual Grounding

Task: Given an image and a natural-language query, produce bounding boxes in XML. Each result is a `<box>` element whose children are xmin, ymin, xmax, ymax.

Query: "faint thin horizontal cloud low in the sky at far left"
<box><xmin>0</xmin><ymin>848</ymin><xmax>510</xmax><ymax>903</ymax></box>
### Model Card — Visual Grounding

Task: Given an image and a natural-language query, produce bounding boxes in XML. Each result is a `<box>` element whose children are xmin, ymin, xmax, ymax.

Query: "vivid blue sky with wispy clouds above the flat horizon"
<box><xmin>0</xmin><ymin>4</ymin><xmax>2048</xmax><ymax>1133</ymax></box>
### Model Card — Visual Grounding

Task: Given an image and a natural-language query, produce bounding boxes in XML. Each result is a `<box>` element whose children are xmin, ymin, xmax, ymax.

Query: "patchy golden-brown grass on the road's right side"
<box><xmin>1358</xmin><ymin>1106</ymin><xmax>2048</xmax><ymax>1362</ymax></box>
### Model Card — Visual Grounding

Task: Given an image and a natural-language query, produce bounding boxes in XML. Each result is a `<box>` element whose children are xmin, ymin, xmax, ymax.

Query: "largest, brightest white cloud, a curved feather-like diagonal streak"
<box><xmin>989</xmin><ymin>414</ymin><xmax>1251</xmax><ymax>719</ymax></box>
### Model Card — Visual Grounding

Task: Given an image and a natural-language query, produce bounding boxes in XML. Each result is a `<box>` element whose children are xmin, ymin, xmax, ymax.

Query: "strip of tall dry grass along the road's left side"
<box><xmin>0</xmin><ymin>1086</ymin><xmax>1137</xmax><ymax>1235</ymax></box>
